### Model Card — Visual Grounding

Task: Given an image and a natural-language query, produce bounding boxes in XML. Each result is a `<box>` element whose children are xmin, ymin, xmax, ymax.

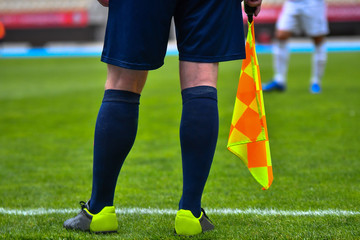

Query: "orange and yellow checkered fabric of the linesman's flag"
<box><xmin>227</xmin><ymin>21</ymin><xmax>273</xmax><ymax>190</ymax></box>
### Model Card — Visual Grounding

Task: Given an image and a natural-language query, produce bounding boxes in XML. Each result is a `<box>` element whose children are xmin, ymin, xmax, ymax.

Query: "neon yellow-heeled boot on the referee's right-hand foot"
<box><xmin>175</xmin><ymin>209</ymin><xmax>214</xmax><ymax>236</ymax></box>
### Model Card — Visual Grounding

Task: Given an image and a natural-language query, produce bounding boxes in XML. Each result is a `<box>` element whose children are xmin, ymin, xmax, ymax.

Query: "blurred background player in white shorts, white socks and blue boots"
<box><xmin>263</xmin><ymin>0</ymin><xmax>329</xmax><ymax>93</ymax></box>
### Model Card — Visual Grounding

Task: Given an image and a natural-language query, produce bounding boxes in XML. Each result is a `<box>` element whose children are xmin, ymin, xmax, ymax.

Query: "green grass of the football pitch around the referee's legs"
<box><xmin>0</xmin><ymin>53</ymin><xmax>360</xmax><ymax>239</ymax></box>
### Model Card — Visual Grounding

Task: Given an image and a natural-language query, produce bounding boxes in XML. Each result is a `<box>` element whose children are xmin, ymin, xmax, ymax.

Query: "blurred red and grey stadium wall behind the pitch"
<box><xmin>0</xmin><ymin>0</ymin><xmax>360</xmax><ymax>46</ymax></box>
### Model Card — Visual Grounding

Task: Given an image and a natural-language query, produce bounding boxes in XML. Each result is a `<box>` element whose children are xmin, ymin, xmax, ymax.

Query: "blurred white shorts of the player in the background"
<box><xmin>276</xmin><ymin>0</ymin><xmax>329</xmax><ymax>37</ymax></box>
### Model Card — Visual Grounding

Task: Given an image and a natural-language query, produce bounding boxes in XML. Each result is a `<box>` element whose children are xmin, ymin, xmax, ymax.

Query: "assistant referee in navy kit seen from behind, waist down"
<box><xmin>64</xmin><ymin>0</ymin><xmax>261</xmax><ymax>235</ymax></box>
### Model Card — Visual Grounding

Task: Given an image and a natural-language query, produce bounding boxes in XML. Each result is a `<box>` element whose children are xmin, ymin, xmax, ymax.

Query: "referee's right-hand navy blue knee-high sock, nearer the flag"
<box><xmin>179</xmin><ymin>86</ymin><xmax>219</xmax><ymax>217</ymax></box>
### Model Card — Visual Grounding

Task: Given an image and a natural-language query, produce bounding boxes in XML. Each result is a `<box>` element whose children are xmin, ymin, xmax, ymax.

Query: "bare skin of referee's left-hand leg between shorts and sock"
<box><xmin>105</xmin><ymin>64</ymin><xmax>148</xmax><ymax>94</ymax></box>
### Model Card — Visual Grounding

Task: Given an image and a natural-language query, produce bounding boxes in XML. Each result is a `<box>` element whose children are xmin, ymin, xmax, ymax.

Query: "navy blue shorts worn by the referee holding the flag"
<box><xmin>101</xmin><ymin>0</ymin><xmax>245</xmax><ymax>70</ymax></box>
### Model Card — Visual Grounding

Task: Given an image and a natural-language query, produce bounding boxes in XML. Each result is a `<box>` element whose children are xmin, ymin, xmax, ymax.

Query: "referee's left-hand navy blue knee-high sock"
<box><xmin>89</xmin><ymin>90</ymin><xmax>140</xmax><ymax>214</ymax></box>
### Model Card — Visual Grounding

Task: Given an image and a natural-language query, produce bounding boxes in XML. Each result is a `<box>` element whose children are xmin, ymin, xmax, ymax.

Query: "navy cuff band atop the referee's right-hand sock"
<box><xmin>181</xmin><ymin>86</ymin><xmax>217</xmax><ymax>103</ymax></box>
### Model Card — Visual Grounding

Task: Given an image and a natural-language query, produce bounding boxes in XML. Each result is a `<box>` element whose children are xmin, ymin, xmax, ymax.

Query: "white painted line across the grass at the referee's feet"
<box><xmin>0</xmin><ymin>208</ymin><xmax>360</xmax><ymax>216</ymax></box>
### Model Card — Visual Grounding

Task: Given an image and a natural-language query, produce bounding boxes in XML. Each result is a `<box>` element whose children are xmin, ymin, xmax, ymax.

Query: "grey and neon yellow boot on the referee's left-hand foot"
<box><xmin>64</xmin><ymin>201</ymin><xmax>118</xmax><ymax>233</ymax></box>
